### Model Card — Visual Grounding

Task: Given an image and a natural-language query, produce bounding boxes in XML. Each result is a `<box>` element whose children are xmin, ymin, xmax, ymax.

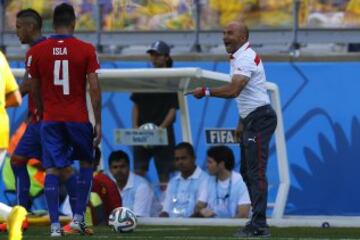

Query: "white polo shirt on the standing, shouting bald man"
<box><xmin>230</xmin><ymin>42</ymin><xmax>270</xmax><ymax>118</ymax></box>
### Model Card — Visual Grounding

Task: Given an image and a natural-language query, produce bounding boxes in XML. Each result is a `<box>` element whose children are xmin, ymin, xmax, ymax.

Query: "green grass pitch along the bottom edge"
<box><xmin>4</xmin><ymin>225</ymin><xmax>360</xmax><ymax>240</ymax></box>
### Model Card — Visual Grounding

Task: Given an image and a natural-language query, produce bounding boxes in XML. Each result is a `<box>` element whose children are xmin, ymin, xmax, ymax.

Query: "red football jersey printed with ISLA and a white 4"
<box><xmin>29</xmin><ymin>35</ymin><xmax>99</xmax><ymax>122</ymax></box>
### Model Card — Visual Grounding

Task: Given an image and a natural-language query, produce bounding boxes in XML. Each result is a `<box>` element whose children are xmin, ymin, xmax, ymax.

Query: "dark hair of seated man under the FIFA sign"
<box><xmin>207</xmin><ymin>146</ymin><xmax>235</xmax><ymax>171</ymax></box>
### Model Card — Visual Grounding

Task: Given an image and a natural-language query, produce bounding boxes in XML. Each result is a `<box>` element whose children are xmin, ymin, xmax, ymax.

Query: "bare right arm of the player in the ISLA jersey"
<box><xmin>87</xmin><ymin>73</ymin><xmax>101</xmax><ymax>146</ymax></box>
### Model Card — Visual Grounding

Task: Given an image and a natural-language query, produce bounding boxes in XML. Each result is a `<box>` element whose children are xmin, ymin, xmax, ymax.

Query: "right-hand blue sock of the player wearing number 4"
<box><xmin>75</xmin><ymin>168</ymin><xmax>94</xmax><ymax>216</ymax></box>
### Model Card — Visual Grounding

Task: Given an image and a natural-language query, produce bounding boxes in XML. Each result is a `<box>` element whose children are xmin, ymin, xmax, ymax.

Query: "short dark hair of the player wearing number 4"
<box><xmin>53</xmin><ymin>3</ymin><xmax>76</xmax><ymax>27</ymax></box>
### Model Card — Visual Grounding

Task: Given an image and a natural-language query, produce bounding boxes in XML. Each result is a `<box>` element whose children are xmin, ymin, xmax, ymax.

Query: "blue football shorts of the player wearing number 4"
<box><xmin>41</xmin><ymin>121</ymin><xmax>94</xmax><ymax>169</ymax></box>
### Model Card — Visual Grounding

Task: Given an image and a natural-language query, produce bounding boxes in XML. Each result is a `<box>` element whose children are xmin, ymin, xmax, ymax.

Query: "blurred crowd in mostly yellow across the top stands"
<box><xmin>5</xmin><ymin>0</ymin><xmax>360</xmax><ymax>31</ymax></box>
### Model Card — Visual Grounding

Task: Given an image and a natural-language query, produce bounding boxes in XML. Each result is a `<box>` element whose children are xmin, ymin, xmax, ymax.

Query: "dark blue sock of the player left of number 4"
<box><xmin>11</xmin><ymin>163</ymin><xmax>30</xmax><ymax>209</ymax></box>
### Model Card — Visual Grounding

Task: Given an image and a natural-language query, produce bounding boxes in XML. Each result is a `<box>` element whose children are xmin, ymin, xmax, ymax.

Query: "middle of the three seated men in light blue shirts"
<box><xmin>160</xmin><ymin>142</ymin><xmax>208</xmax><ymax>217</ymax></box>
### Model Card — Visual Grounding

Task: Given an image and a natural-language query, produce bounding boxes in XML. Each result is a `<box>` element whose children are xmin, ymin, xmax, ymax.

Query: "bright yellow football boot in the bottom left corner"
<box><xmin>7</xmin><ymin>206</ymin><xmax>27</xmax><ymax>240</ymax></box>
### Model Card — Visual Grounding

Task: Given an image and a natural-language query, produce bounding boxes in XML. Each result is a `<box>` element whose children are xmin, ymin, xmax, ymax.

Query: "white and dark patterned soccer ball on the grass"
<box><xmin>108</xmin><ymin>207</ymin><xmax>137</xmax><ymax>233</ymax></box>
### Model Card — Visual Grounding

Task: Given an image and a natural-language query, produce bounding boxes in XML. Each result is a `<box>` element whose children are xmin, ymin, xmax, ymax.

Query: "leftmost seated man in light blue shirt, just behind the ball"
<box><xmin>108</xmin><ymin>150</ymin><xmax>154</xmax><ymax>217</ymax></box>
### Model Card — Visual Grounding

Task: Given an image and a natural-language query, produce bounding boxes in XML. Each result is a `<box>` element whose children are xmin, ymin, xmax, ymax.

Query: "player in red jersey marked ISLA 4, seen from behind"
<box><xmin>30</xmin><ymin>3</ymin><xmax>101</xmax><ymax>237</ymax></box>
